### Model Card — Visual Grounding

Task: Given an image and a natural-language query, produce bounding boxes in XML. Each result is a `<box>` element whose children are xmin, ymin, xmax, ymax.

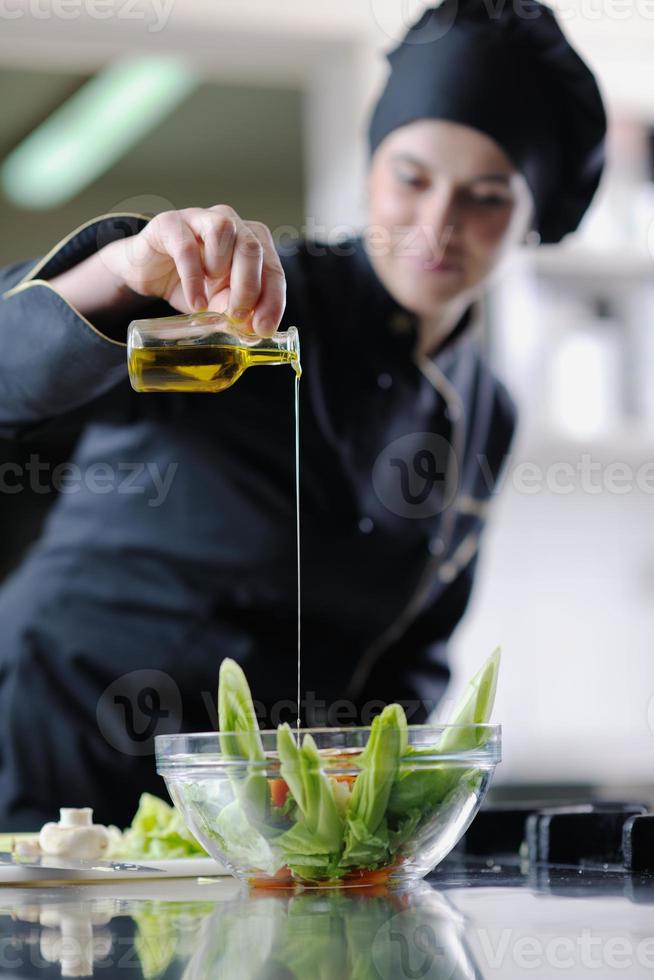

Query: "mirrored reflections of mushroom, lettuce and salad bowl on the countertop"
<box><xmin>0</xmin><ymin>882</ymin><xmax>472</xmax><ymax>980</ymax></box>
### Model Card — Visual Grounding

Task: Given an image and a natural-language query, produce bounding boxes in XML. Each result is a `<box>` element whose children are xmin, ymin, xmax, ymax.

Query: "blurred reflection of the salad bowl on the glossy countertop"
<box><xmin>182</xmin><ymin>886</ymin><xmax>481</xmax><ymax>980</ymax></box>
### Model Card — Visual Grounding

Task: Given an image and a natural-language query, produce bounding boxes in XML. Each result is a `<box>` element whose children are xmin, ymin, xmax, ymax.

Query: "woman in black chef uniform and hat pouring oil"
<box><xmin>0</xmin><ymin>0</ymin><xmax>605</xmax><ymax>830</ymax></box>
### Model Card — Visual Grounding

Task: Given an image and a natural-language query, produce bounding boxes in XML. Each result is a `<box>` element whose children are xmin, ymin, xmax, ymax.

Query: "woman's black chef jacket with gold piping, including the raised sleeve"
<box><xmin>0</xmin><ymin>215</ymin><xmax>514</xmax><ymax>830</ymax></box>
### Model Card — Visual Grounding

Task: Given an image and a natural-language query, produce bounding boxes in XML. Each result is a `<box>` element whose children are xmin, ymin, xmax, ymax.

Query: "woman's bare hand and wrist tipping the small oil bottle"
<box><xmin>52</xmin><ymin>204</ymin><xmax>286</xmax><ymax>336</ymax></box>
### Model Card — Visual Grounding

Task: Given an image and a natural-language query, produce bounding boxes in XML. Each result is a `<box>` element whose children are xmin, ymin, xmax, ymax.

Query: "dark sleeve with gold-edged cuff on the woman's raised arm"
<box><xmin>0</xmin><ymin>214</ymin><xmax>156</xmax><ymax>438</ymax></box>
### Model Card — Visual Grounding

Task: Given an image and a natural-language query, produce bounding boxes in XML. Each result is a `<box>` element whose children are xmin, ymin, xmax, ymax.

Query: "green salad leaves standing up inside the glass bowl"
<box><xmin>200</xmin><ymin>651</ymin><xmax>499</xmax><ymax>880</ymax></box>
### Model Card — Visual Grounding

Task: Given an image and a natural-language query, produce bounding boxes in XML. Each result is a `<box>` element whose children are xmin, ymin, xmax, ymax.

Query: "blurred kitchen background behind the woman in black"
<box><xmin>0</xmin><ymin>0</ymin><xmax>654</xmax><ymax>792</ymax></box>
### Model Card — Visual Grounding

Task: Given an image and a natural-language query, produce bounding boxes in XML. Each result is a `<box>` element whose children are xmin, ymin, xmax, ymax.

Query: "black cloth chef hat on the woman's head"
<box><xmin>369</xmin><ymin>0</ymin><xmax>606</xmax><ymax>243</ymax></box>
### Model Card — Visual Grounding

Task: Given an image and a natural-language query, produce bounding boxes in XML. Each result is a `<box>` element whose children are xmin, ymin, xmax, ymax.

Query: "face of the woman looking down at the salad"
<box><xmin>365</xmin><ymin>119</ymin><xmax>532</xmax><ymax>316</ymax></box>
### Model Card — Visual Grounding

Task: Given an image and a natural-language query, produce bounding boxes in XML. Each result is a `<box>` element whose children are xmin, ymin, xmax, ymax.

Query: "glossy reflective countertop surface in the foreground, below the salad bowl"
<box><xmin>0</xmin><ymin>856</ymin><xmax>654</xmax><ymax>980</ymax></box>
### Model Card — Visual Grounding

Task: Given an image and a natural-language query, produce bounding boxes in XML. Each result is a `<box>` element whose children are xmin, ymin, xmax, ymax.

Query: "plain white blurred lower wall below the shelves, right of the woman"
<box><xmin>454</xmin><ymin>433</ymin><xmax>654</xmax><ymax>783</ymax></box>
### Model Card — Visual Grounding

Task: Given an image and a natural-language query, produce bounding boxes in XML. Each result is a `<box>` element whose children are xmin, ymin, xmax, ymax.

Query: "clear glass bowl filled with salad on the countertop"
<box><xmin>156</xmin><ymin>720</ymin><xmax>501</xmax><ymax>887</ymax></box>
